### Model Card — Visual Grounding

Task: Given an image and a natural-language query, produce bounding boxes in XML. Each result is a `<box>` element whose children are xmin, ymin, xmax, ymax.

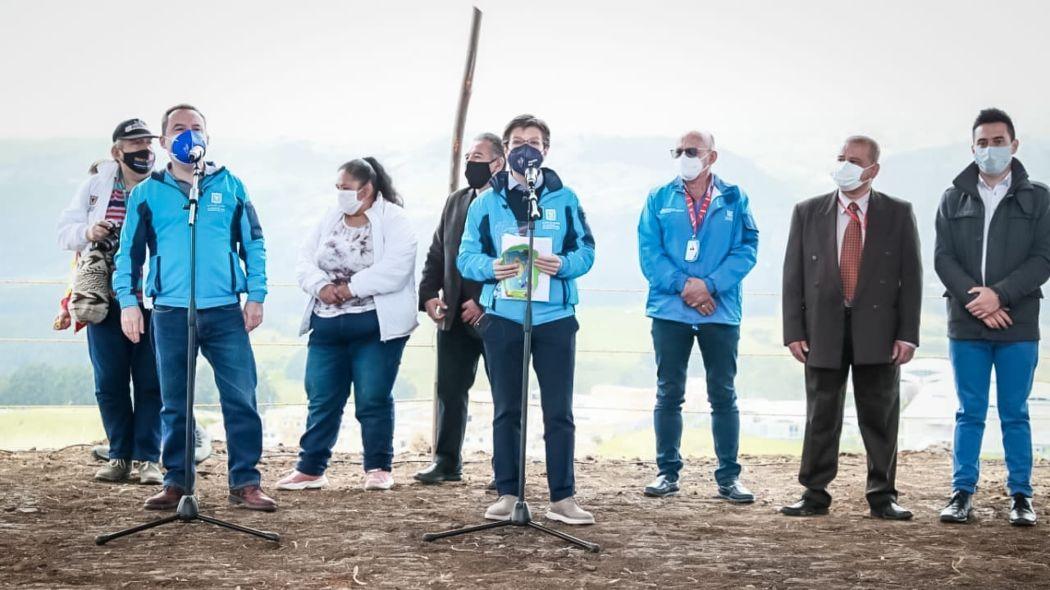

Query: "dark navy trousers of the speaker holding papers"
<box><xmin>483</xmin><ymin>316</ymin><xmax>580</xmax><ymax>502</ymax></box>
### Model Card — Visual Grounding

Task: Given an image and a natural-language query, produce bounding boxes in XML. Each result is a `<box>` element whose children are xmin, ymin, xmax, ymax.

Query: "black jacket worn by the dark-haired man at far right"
<box><xmin>935</xmin><ymin>160</ymin><xmax>1050</xmax><ymax>342</ymax></box>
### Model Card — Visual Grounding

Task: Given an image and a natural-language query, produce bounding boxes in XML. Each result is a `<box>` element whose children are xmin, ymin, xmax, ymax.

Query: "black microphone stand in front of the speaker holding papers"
<box><xmin>423</xmin><ymin>168</ymin><xmax>602</xmax><ymax>553</ymax></box>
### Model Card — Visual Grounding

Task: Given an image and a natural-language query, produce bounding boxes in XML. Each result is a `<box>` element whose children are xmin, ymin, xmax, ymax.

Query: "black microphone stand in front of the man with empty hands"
<box><xmin>95</xmin><ymin>157</ymin><xmax>280</xmax><ymax>545</ymax></box>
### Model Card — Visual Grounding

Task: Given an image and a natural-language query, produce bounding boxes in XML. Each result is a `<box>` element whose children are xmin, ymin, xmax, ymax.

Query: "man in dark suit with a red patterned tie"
<box><xmin>780</xmin><ymin>135</ymin><xmax>922</xmax><ymax>520</ymax></box>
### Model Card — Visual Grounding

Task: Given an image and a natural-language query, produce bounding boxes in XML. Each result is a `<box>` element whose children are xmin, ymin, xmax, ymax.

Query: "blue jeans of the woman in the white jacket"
<box><xmin>295</xmin><ymin>311</ymin><xmax>408</xmax><ymax>476</ymax></box>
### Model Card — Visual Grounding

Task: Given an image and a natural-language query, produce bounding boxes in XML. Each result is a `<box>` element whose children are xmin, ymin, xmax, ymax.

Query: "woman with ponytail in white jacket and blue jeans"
<box><xmin>277</xmin><ymin>157</ymin><xmax>417</xmax><ymax>490</ymax></box>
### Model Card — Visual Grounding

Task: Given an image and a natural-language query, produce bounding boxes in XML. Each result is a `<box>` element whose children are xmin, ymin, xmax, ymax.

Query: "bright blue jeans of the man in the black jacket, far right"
<box><xmin>948</xmin><ymin>340</ymin><xmax>1040</xmax><ymax>498</ymax></box>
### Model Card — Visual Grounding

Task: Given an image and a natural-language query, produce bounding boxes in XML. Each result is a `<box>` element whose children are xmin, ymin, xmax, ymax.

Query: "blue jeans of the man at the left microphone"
<box><xmin>153</xmin><ymin>303</ymin><xmax>263</xmax><ymax>491</ymax></box>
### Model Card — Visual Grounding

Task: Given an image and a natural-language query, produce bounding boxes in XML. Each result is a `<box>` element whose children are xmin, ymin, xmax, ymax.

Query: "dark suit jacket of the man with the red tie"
<box><xmin>782</xmin><ymin>190</ymin><xmax>922</xmax><ymax>368</ymax></box>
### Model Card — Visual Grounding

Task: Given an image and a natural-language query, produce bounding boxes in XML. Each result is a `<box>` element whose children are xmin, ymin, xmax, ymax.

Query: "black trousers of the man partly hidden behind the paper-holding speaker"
<box><xmin>434</xmin><ymin>317</ymin><xmax>487</xmax><ymax>473</ymax></box>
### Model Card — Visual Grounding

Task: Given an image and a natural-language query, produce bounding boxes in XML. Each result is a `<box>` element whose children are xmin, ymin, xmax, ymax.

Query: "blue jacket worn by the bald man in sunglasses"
<box><xmin>638</xmin><ymin>175</ymin><xmax>758</xmax><ymax>325</ymax></box>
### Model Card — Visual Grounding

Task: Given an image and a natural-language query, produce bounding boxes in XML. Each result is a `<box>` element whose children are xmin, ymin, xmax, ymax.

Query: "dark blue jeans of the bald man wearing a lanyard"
<box><xmin>652</xmin><ymin>319</ymin><xmax>740</xmax><ymax>485</ymax></box>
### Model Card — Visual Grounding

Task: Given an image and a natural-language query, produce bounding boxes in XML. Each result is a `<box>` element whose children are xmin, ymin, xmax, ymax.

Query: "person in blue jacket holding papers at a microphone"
<box><xmin>457</xmin><ymin>114</ymin><xmax>594</xmax><ymax>525</ymax></box>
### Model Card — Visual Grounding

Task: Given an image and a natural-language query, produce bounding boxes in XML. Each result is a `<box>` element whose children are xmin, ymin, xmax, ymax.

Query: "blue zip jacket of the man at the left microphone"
<box><xmin>113</xmin><ymin>163</ymin><xmax>267</xmax><ymax>309</ymax></box>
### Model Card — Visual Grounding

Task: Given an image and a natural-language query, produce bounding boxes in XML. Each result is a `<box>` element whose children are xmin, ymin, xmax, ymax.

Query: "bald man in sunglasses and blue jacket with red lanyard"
<box><xmin>638</xmin><ymin>131</ymin><xmax>758</xmax><ymax>504</ymax></box>
